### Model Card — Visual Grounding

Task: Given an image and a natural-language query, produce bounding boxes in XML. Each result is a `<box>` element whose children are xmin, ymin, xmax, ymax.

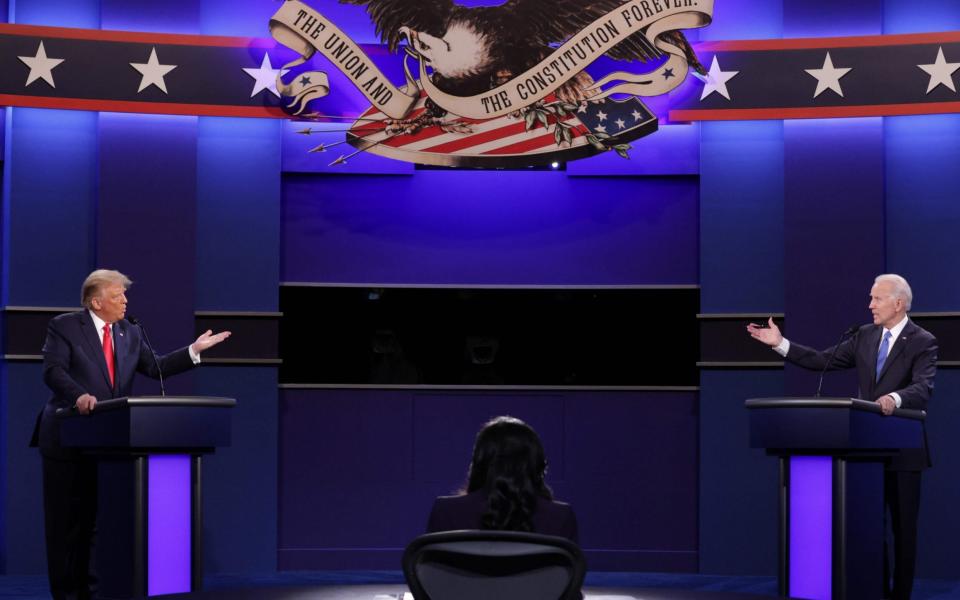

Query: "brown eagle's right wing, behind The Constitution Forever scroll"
<box><xmin>496</xmin><ymin>0</ymin><xmax>686</xmax><ymax>61</ymax></box>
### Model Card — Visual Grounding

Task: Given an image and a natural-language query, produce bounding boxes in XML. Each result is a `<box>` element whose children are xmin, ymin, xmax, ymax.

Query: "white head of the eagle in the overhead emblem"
<box><xmin>400</xmin><ymin>20</ymin><xmax>494</xmax><ymax>80</ymax></box>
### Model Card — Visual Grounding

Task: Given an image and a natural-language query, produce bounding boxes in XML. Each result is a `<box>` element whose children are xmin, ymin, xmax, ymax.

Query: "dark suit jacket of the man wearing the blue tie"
<box><xmin>786</xmin><ymin>321</ymin><xmax>937</xmax><ymax>471</ymax></box>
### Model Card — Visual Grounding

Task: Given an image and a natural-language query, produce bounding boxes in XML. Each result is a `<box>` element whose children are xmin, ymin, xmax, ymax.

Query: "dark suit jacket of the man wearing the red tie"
<box><xmin>30</xmin><ymin>310</ymin><xmax>194</xmax><ymax>458</ymax></box>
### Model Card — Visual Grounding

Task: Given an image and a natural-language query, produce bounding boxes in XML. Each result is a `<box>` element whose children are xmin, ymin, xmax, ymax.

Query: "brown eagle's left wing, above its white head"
<box><xmin>340</xmin><ymin>0</ymin><xmax>454</xmax><ymax>51</ymax></box>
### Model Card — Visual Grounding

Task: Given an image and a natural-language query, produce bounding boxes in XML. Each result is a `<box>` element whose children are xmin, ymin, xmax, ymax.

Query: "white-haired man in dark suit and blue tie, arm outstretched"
<box><xmin>747</xmin><ymin>275</ymin><xmax>937</xmax><ymax>600</ymax></box>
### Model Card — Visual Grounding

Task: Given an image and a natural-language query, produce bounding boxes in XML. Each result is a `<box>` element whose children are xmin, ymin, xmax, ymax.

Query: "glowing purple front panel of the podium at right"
<box><xmin>789</xmin><ymin>456</ymin><xmax>833</xmax><ymax>600</ymax></box>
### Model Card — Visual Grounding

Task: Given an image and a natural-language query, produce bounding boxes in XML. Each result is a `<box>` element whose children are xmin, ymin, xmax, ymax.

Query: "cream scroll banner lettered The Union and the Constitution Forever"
<box><xmin>270</xmin><ymin>0</ymin><xmax>713</xmax><ymax>119</ymax></box>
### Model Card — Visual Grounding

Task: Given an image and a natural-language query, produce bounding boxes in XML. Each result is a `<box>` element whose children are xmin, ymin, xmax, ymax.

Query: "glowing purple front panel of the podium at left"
<box><xmin>147</xmin><ymin>455</ymin><xmax>190</xmax><ymax>596</ymax></box>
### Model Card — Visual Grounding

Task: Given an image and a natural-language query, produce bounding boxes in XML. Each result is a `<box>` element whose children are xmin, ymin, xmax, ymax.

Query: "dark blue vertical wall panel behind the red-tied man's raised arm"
<box><xmin>97</xmin><ymin>113</ymin><xmax>197</xmax><ymax>395</ymax></box>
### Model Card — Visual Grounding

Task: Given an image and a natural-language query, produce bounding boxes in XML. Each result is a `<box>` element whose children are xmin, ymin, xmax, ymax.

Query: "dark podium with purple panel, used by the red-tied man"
<box><xmin>57</xmin><ymin>396</ymin><xmax>236</xmax><ymax>599</ymax></box>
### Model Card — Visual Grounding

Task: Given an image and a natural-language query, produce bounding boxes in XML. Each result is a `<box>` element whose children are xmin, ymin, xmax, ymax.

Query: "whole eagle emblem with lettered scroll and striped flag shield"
<box><xmin>271</xmin><ymin>0</ymin><xmax>712</xmax><ymax>167</ymax></box>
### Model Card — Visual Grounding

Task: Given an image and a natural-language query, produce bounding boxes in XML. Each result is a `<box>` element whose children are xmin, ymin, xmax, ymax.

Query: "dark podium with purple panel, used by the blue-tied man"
<box><xmin>745</xmin><ymin>398</ymin><xmax>926</xmax><ymax>600</ymax></box>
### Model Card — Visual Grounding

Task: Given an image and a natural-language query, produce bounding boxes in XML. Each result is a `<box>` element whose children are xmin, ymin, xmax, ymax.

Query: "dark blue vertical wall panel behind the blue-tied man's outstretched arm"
<box><xmin>784</xmin><ymin>119</ymin><xmax>886</xmax><ymax>395</ymax></box>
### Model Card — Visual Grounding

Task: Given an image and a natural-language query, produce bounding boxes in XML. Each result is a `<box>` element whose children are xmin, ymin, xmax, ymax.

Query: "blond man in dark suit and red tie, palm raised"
<box><xmin>31</xmin><ymin>269</ymin><xmax>230</xmax><ymax>600</ymax></box>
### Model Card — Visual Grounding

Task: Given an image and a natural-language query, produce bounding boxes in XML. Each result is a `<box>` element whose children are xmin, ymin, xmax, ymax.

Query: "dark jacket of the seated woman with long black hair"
<box><xmin>427</xmin><ymin>491</ymin><xmax>578</xmax><ymax>543</ymax></box>
